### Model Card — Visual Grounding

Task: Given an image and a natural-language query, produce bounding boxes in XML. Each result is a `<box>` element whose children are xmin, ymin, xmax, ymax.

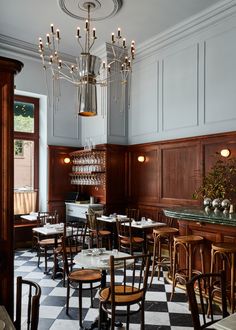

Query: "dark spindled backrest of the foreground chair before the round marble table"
<box><xmin>110</xmin><ymin>254</ymin><xmax>151</xmax><ymax>308</ymax></box>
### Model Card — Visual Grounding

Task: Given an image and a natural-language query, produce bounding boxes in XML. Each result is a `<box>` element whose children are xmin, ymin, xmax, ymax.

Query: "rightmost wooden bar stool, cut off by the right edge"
<box><xmin>211</xmin><ymin>242</ymin><xmax>236</xmax><ymax>313</ymax></box>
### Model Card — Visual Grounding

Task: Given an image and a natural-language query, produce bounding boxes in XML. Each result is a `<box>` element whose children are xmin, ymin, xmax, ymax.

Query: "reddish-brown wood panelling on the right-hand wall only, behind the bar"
<box><xmin>127</xmin><ymin>132</ymin><xmax>236</xmax><ymax>219</ymax></box>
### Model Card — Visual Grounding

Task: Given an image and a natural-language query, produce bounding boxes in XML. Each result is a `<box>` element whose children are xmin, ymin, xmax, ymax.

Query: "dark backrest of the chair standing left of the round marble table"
<box><xmin>62</xmin><ymin>227</ymin><xmax>89</xmax><ymax>276</ymax></box>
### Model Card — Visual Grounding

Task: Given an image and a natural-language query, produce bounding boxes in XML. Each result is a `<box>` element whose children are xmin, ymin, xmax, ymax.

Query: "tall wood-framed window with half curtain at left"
<box><xmin>14</xmin><ymin>95</ymin><xmax>39</xmax><ymax>214</ymax></box>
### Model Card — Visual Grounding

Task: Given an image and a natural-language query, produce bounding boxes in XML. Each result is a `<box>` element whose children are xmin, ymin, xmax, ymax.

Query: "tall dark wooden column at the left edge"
<box><xmin>0</xmin><ymin>57</ymin><xmax>23</xmax><ymax>317</ymax></box>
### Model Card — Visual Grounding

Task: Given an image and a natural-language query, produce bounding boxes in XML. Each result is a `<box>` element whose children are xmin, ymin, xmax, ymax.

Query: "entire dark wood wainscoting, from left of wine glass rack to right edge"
<box><xmin>48</xmin><ymin>132</ymin><xmax>236</xmax><ymax>219</ymax></box>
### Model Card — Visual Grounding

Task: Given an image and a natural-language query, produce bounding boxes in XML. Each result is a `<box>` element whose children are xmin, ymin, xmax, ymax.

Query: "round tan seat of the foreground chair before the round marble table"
<box><xmin>99</xmin><ymin>285</ymin><xmax>143</xmax><ymax>305</ymax></box>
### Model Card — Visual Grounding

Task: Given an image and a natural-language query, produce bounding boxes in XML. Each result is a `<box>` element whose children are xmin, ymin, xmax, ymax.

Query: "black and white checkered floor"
<box><xmin>15</xmin><ymin>250</ymin><xmax>193</xmax><ymax>330</ymax></box>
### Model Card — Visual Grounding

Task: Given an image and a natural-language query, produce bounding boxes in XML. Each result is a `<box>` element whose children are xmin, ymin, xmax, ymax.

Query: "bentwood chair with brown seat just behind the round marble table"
<box><xmin>116</xmin><ymin>218</ymin><xmax>145</xmax><ymax>255</ymax></box>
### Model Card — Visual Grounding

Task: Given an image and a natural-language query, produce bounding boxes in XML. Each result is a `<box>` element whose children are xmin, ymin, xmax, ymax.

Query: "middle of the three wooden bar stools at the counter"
<box><xmin>170</xmin><ymin>235</ymin><xmax>204</xmax><ymax>300</ymax></box>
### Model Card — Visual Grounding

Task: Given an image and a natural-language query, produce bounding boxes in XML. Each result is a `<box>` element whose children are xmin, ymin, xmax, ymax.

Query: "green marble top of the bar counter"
<box><xmin>163</xmin><ymin>207</ymin><xmax>236</xmax><ymax>227</ymax></box>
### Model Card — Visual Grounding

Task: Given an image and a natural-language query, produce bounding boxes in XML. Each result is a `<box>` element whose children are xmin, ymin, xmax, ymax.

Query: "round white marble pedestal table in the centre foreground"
<box><xmin>74</xmin><ymin>248</ymin><xmax>133</xmax><ymax>329</ymax></box>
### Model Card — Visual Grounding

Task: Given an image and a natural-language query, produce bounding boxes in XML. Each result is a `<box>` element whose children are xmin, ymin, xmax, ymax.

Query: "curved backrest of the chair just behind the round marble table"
<box><xmin>116</xmin><ymin>218</ymin><xmax>133</xmax><ymax>253</ymax></box>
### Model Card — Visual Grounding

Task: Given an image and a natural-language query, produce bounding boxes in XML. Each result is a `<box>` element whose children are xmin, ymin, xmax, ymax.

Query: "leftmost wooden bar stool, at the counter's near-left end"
<box><xmin>150</xmin><ymin>227</ymin><xmax>179</xmax><ymax>287</ymax></box>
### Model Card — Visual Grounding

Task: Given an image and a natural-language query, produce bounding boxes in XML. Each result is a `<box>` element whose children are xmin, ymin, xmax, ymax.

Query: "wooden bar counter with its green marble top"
<box><xmin>163</xmin><ymin>207</ymin><xmax>236</xmax><ymax>272</ymax></box>
